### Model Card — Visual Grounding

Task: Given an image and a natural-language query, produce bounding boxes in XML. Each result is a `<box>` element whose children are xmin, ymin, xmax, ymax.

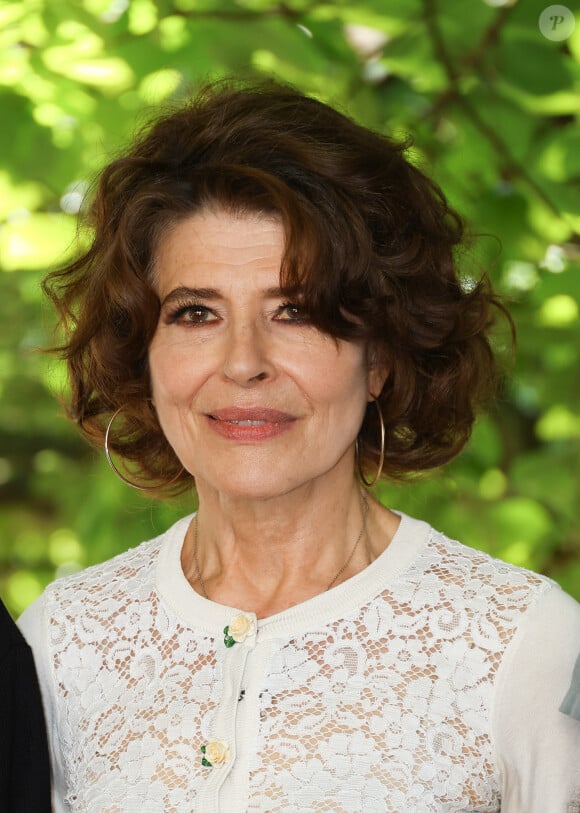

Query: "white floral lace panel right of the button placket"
<box><xmin>248</xmin><ymin>535</ymin><xmax>546</xmax><ymax>813</ymax></box>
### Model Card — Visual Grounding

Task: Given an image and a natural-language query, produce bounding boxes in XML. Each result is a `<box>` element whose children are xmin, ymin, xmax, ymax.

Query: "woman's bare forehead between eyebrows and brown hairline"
<box><xmin>155</xmin><ymin>210</ymin><xmax>285</xmax><ymax>288</ymax></box>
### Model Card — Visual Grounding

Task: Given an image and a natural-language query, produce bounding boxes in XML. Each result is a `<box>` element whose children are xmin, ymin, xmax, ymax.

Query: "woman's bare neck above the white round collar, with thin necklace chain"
<box><xmin>182</xmin><ymin>472</ymin><xmax>396</xmax><ymax>617</ymax></box>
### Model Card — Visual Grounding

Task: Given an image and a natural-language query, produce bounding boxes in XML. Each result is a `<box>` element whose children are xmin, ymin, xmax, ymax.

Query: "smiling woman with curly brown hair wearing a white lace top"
<box><xmin>22</xmin><ymin>85</ymin><xmax>580</xmax><ymax>813</ymax></box>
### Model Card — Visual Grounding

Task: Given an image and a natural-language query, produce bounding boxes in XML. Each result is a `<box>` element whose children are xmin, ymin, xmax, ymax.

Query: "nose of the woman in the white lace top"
<box><xmin>223</xmin><ymin>322</ymin><xmax>274</xmax><ymax>387</ymax></box>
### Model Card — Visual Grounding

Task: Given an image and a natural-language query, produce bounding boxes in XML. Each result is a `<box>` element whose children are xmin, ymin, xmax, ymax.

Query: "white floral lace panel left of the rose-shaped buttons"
<box><xmin>44</xmin><ymin>544</ymin><xmax>220</xmax><ymax>813</ymax></box>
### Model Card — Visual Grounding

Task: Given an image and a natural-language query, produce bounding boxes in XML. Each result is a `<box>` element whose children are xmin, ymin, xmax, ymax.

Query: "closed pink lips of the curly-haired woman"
<box><xmin>206</xmin><ymin>407</ymin><xmax>296</xmax><ymax>442</ymax></box>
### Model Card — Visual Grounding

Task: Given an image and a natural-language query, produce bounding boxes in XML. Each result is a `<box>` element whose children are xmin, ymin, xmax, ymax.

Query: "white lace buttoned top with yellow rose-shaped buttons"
<box><xmin>21</xmin><ymin>516</ymin><xmax>580</xmax><ymax>813</ymax></box>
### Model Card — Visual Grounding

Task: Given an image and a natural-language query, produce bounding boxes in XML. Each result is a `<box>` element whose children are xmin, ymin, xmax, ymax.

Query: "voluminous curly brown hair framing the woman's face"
<box><xmin>44</xmin><ymin>82</ymin><xmax>509</xmax><ymax>493</ymax></box>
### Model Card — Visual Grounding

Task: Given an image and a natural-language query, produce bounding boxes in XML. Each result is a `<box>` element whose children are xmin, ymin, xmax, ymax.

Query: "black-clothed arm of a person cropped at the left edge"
<box><xmin>0</xmin><ymin>601</ymin><xmax>50</xmax><ymax>813</ymax></box>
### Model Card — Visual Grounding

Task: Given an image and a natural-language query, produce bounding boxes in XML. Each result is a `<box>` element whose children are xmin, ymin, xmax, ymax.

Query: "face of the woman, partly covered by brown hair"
<box><xmin>149</xmin><ymin>210</ymin><xmax>383</xmax><ymax>499</ymax></box>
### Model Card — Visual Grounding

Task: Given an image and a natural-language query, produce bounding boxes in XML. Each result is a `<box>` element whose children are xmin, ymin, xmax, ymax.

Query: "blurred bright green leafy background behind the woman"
<box><xmin>0</xmin><ymin>0</ymin><xmax>580</xmax><ymax>614</ymax></box>
